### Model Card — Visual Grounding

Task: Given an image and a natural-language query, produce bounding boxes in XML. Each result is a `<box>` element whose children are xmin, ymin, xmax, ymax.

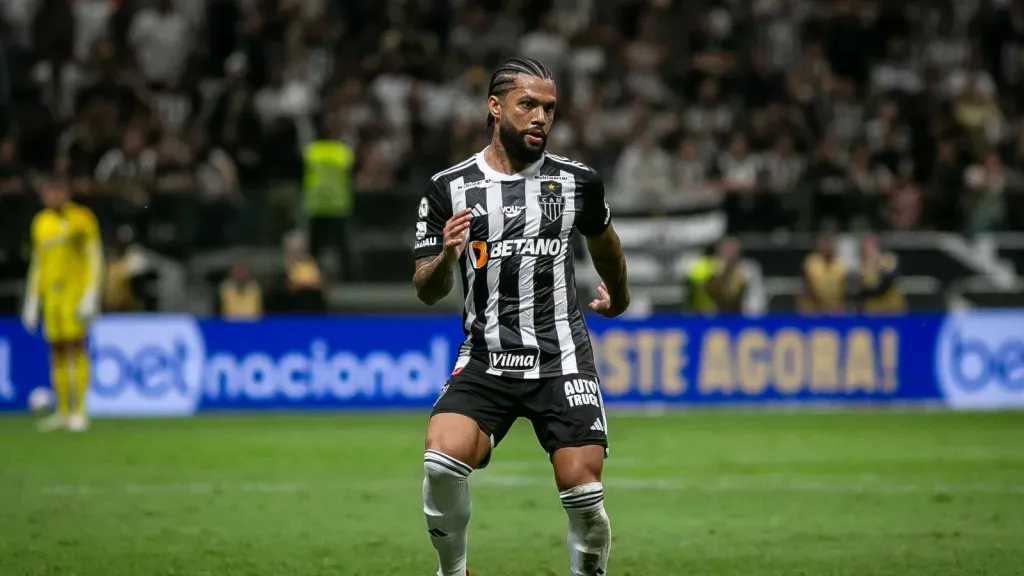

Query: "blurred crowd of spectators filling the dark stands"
<box><xmin>0</xmin><ymin>0</ymin><xmax>1024</xmax><ymax>270</ymax></box>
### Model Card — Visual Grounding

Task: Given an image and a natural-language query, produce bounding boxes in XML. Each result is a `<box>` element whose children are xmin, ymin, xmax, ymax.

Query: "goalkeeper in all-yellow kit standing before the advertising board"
<box><xmin>22</xmin><ymin>180</ymin><xmax>103</xmax><ymax>431</ymax></box>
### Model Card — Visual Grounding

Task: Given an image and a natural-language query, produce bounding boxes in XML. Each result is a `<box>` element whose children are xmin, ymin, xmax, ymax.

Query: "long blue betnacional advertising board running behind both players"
<box><xmin>0</xmin><ymin>311</ymin><xmax>1024</xmax><ymax>416</ymax></box>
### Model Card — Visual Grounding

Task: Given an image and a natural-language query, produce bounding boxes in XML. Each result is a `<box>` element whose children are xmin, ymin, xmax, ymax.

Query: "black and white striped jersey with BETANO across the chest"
<box><xmin>414</xmin><ymin>152</ymin><xmax>611</xmax><ymax>378</ymax></box>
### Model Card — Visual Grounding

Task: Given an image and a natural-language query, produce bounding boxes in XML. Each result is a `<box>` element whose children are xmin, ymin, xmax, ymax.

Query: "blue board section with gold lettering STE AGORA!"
<box><xmin>594</xmin><ymin>317</ymin><xmax>942</xmax><ymax>404</ymax></box>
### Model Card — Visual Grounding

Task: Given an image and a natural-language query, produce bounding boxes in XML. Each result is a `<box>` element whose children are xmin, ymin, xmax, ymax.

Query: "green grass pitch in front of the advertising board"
<box><xmin>0</xmin><ymin>411</ymin><xmax>1024</xmax><ymax>576</ymax></box>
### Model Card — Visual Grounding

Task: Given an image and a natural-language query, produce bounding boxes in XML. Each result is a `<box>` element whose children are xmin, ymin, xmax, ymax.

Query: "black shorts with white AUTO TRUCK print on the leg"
<box><xmin>430</xmin><ymin>368</ymin><xmax>608</xmax><ymax>468</ymax></box>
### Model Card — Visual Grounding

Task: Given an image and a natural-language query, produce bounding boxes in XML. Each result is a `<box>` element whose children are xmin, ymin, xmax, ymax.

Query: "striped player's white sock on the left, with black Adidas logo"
<box><xmin>423</xmin><ymin>450</ymin><xmax>473</xmax><ymax>576</ymax></box>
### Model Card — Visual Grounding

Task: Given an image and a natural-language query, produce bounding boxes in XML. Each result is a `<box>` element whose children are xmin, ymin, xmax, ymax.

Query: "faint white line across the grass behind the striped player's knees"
<box><xmin>42</xmin><ymin>470</ymin><xmax>1024</xmax><ymax>497</ymax></box>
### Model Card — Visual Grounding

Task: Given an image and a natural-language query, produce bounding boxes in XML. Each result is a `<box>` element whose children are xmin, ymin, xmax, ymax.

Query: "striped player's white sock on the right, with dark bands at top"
<box><xmin>558</xmin><ymin>482</ymin><xmax>611</xmax><ymax>576</ymax></box>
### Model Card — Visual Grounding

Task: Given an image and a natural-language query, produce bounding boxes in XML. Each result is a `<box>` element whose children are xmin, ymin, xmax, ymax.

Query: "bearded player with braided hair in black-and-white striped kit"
<box><xmin>414</xmin><ymin>58</ymin><xmax>630</xmax><ymax>576</ymax></box>
